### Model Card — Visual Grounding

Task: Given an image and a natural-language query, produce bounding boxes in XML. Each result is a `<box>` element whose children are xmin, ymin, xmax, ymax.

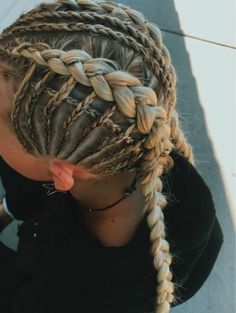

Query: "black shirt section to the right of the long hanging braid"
<box><xmin>164</xmin><ymin>154</ymin><xmax>223</xmax><ymax>306</ymax></box>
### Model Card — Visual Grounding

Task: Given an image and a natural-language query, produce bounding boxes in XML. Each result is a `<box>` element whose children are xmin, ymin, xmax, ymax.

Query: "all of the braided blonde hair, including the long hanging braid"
<box><xmin>0</xmin><ymin>0</ymin><xmax>194</xmax><ymax>313</ymax></box>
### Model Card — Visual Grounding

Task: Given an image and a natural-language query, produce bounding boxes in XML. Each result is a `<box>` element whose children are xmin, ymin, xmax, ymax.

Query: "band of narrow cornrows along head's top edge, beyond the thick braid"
<box><xmin>2</xmin><ymin>0</ymin><xmax>175</xmax><ymax>120</ymax></box>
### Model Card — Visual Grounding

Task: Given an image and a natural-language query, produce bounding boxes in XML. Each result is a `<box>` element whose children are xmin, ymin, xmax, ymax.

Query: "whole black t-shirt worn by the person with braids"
<box><xmin>0</xmin><ymin>152</ymin><xmax>223</xmax><ymax>313</ymax></box>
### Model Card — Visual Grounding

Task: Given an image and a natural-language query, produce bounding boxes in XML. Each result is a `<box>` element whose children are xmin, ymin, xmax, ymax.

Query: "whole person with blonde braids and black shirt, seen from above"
<box><xmin>0</xmin><ymin>0</ymin><xmax>223</xmax><ymax>313</ymax></box>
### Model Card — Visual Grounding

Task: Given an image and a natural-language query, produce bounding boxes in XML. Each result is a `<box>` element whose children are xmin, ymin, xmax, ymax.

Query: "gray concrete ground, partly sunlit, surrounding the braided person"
<box><xmin>0</xmin><ymin>0</ymin><xmax>236</xmax><ymax>313</ymax></box>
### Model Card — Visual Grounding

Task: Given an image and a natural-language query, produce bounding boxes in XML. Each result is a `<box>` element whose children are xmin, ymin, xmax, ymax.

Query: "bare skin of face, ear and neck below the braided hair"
<box><xmin>0</xmin><ymin>67</ymin><xmax>144</xmax><ymax>246</ymax></box>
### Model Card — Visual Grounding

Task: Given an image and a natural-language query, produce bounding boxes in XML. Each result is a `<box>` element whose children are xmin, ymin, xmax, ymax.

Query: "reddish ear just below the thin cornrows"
<box><xmin>49</xmin><ymin>161</ymin><xmax>74</xmax><ymax>191</ymax></box>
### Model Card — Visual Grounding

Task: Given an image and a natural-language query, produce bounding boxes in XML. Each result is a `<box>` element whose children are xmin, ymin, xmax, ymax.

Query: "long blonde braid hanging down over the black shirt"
<box><xmin>140</xmin><ymin>109</ymin><xmax>177</xmax><ymax>313</ymax></box>
